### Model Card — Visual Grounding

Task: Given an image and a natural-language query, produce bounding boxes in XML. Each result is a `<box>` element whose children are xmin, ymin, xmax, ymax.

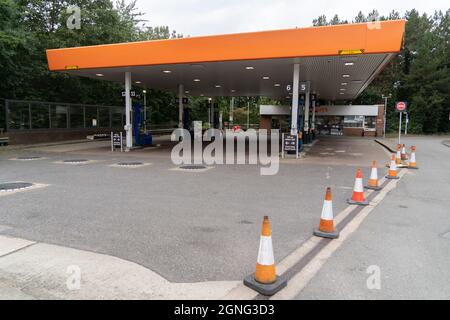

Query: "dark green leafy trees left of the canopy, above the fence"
<box><xmin>0</xmin><ymin>0</ymin><xmax>181</xmax><ymax>128</ymax></box>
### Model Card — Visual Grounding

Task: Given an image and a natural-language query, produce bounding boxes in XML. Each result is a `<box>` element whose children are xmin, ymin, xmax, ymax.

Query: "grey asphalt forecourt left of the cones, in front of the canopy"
<box><xmin>0</xmin><ymin>138</ymin><xmax>412</xmax><ymax>299</ymax></box>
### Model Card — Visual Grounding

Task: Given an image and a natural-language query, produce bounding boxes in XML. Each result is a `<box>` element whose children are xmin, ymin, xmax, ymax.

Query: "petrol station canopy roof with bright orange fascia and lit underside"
<box><xmin>47</xmin><ymin>20</ymin><xmax>405</xmax><ymax>100</ymax></box>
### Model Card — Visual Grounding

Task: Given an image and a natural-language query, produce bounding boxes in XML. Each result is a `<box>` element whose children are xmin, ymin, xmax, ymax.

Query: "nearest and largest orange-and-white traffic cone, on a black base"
<box><xmin>244</xmin><ymin>216</ymin><xmax>287</xmax><ymax>296</ymax></box>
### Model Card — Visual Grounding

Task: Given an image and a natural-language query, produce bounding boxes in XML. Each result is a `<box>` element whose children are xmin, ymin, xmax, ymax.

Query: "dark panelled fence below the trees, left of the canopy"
<box><xmin>0</xmin><ymin>100</ymin><xmax>125</xmax><ymax>131</ymax></box>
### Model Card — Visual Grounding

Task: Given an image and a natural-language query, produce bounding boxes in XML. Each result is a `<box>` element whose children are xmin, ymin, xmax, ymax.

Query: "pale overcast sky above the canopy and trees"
<box><xmin>137</xmin><ymin>0</ymin><xmax>450</xmax><ymax>36</ymax></box>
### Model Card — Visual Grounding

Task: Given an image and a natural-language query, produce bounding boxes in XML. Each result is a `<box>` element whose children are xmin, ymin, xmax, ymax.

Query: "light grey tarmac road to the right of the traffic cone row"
<box><xmin>297</xmin><ymin>137</ymin><xmax>450</xmax><ymax>299</ymax></box>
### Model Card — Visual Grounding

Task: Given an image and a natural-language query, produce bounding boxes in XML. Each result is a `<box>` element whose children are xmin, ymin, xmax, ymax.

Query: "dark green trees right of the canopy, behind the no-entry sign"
<box><xmin>326</xmin><ymin>10</ymin><xmax>450</xmax><ymax>133</ymax></box>
